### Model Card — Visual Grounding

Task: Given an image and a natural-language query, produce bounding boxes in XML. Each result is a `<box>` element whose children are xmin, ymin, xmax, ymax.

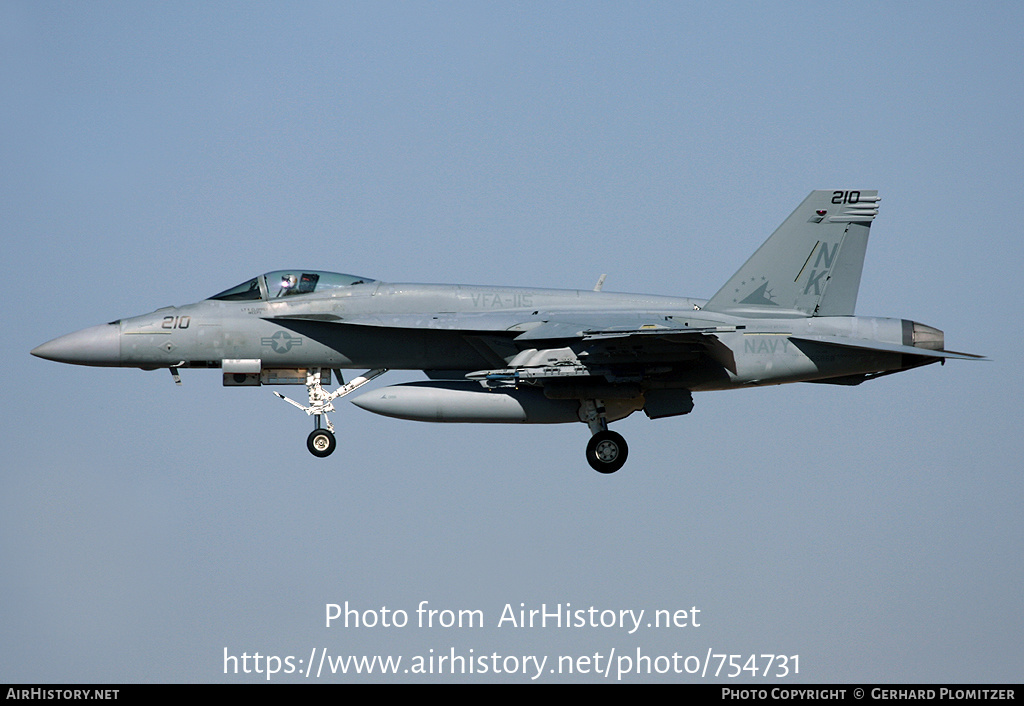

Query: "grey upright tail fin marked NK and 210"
<box><xmin>703</xmin><ymin>191</ymin><xmax>880</xmax><ymax>317</ymax></box>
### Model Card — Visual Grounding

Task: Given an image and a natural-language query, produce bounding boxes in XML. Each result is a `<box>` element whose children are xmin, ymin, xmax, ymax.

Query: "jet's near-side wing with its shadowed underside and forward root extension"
<box><xmin>272</xmin><ymin>312</ymin><xmax>737</xmax><ymax>407</ymax></box>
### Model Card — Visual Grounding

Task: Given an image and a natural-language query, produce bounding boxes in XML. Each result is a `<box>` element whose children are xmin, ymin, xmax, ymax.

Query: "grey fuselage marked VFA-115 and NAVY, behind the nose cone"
<box><xmin>99</xmin><ymin>282</ymin><xmax>906</xmax><ymax>390</ymax></box>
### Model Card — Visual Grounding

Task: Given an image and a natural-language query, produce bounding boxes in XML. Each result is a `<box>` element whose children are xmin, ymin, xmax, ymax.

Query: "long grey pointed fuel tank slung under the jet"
<box><xmin>352</xmin><ymin>380</ymin><xmax>643</xmax><ymax>424</ymax></box>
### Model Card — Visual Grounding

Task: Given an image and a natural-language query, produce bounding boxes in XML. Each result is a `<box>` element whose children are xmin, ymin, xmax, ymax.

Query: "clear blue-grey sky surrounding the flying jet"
<box><xmin>0</xmin><ymin>2</ymin><xmax>1024</xmax><ymax>683</ymax></box>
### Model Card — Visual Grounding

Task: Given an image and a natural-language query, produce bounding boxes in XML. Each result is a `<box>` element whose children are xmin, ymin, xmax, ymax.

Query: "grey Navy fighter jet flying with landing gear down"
<box><xmin>32</xmin><ymin>190</ymin><xmax>982</xmax><ymax>473</ymax></box>
